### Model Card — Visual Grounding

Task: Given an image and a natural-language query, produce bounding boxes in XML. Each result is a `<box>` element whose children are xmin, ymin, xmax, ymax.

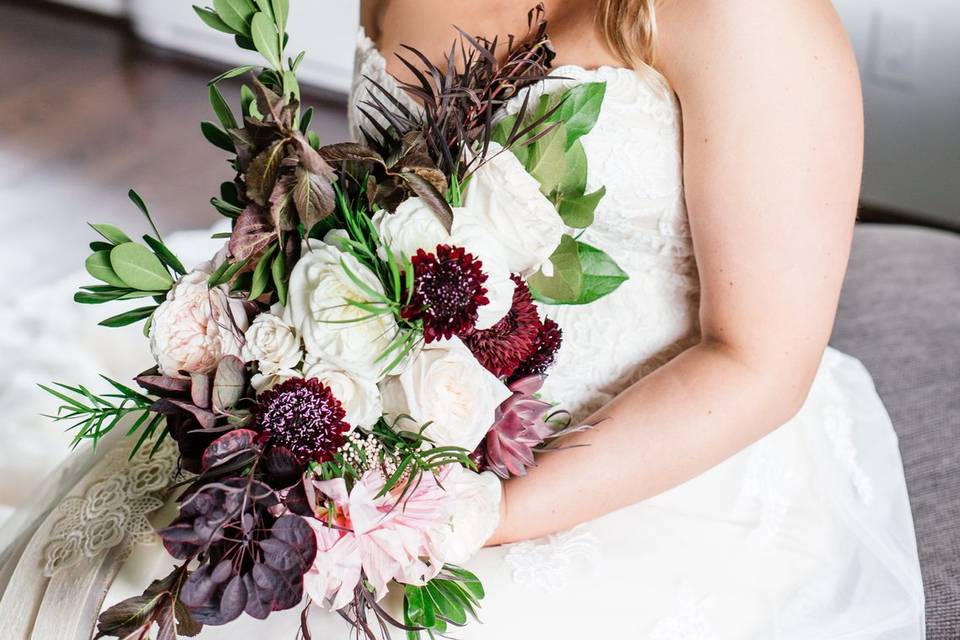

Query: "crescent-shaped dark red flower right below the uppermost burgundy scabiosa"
<box><xmin>463</xmin><ymin>275</ymin><xmax>543</xmax><ymax>377</ymax></box>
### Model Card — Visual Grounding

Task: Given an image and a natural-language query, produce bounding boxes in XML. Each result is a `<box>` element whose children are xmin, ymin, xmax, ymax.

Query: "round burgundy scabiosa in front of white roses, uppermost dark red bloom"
<box><xmin>402</xmin><ymin>244</ymin><xmax>488</xmax><ymax>342</ymax></box>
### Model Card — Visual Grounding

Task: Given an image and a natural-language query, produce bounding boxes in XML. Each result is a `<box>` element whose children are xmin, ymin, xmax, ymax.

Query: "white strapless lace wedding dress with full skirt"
<box><xmin>0</xmin><ymin>27</ymin><xmax>924</xmax><ymax>640</ymax></box>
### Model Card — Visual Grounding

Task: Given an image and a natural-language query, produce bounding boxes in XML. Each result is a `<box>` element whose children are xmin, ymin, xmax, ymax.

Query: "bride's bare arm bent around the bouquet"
<box><xmin>490</xmin><ymin>0</ymin><xmax>862</xmax><ymax>544</ymax></box>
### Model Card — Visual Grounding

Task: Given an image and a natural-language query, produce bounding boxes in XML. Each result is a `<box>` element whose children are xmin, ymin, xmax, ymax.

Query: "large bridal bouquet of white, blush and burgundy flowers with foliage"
<box><xmin>44</xmin><ymin>0</ymin><xmax>626</xmax><ymax>640</ymax></box>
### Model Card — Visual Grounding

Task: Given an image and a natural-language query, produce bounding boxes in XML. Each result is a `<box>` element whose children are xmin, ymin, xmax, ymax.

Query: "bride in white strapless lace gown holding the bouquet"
<box><xmin>0</xmin><ymin>0</ymin><xmax>924</xmax><ymax>640</ymax></box>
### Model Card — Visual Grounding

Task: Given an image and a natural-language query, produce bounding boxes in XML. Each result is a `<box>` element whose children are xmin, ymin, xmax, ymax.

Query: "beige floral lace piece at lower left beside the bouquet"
<box><xmin>43</xmin><ymin>441</ymin><xmax>178</xmax><ymax>577</ymax></box>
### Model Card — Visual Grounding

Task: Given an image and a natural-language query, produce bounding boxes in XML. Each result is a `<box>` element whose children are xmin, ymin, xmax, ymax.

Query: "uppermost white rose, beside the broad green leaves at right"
<box><xmin>463</xmin><ymin>142</ymin><xmax>565</xmax><ymax>277</ymax></box>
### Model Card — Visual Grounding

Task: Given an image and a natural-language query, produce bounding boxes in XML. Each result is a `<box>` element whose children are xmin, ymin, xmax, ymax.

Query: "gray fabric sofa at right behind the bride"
<box><xmin>831</xmin><ymin>224</ymin><xmax>960</xmax><ymax>640</ymax></box>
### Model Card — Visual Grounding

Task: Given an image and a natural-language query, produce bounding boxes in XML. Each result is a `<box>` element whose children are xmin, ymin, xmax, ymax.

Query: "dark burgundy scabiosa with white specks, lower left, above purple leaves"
<box><xmin>253</xmin><ymin>378</ymin><xmax>350</xmax><ymax>463</ymax></box>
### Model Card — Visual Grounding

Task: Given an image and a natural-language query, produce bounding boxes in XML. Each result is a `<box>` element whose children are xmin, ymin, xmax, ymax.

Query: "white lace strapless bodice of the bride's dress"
<box><xmin>349</xmin><ymin>30</ymin><xmax>699</xmax><ymax>418</ymax></box>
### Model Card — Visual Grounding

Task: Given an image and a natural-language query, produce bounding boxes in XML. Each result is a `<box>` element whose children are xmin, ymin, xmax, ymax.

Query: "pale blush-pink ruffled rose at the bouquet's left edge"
<box><xmin>150</xmin><ymin>265</ymin><xmax>247</xmax><ymax>378</ymax></box>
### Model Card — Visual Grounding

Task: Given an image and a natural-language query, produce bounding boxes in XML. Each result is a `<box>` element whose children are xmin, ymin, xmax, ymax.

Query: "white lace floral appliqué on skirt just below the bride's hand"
<box><xmin>504</xmin><ymin>525</ymin><xmax>600</xmax><ymax>592</ymax></box>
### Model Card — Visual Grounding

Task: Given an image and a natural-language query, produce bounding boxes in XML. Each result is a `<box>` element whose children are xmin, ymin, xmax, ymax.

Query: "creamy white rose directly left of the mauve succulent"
<box><xmin>380</xmin><ymin>338</ymin><xmax>512</xmax><ymax>451</ymax></box>
